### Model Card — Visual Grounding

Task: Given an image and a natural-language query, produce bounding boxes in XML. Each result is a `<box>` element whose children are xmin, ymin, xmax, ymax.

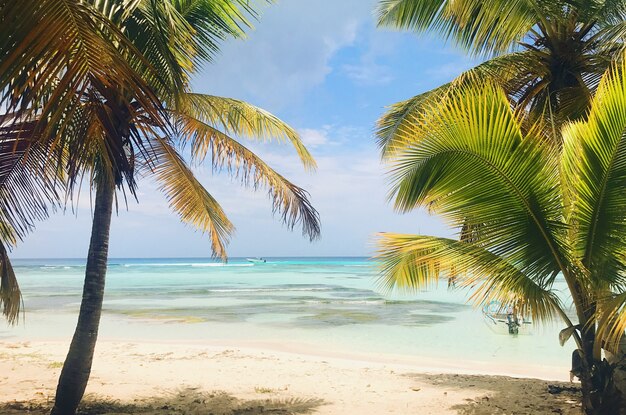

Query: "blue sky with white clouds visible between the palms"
<box><xmin>12</xmin><ymin>0</ymin><xmax>476</xmax><ymax>258</ymax></box>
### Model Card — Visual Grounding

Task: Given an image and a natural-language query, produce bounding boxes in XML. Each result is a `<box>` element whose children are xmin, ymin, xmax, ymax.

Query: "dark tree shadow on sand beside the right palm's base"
<box><xmin>409</xmin><ymin>374</ymin><xmax>582</xmax><ymax>415</ymax></box>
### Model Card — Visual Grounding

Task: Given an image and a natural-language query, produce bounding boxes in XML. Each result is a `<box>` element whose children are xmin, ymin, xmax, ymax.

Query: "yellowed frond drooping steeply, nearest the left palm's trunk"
<box><xmin>150</xmin><ymin>138</ymin><xmax>234</xmax><ymax>260</ymax></box>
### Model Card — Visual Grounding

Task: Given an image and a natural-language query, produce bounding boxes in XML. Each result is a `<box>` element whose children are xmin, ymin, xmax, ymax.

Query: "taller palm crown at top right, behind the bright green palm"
<box><xmin>377</xmin><ymin>0</ymin><xmax>626</xmax><ymax>156</ymax></box>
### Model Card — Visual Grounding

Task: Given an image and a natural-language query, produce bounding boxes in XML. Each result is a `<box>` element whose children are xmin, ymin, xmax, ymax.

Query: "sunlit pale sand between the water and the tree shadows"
<box><xmin>0</xmin><ymin>339</ymin><xmax>580</xmax><ymax>415</ymax></box>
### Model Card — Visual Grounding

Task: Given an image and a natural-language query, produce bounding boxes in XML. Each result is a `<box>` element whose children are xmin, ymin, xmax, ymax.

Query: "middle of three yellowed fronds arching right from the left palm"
<box><xmin>174</xmin><ymin>112</ymin><xmax>320</xmax><ymax>240</ymax></box>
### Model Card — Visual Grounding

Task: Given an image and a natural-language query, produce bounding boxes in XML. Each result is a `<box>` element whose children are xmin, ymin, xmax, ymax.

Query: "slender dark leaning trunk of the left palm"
<box><xmin>51</xmin><ymin>179</ymin><xmax>115</xmax><ymax>415</ymax></box>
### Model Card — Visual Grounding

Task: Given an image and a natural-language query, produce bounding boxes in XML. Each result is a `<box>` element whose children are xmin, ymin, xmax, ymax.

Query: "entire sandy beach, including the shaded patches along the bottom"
<box><xmin>0</xmin><ymin>340</ymin><xmax>579</xmax><ymax>415</ymax></box>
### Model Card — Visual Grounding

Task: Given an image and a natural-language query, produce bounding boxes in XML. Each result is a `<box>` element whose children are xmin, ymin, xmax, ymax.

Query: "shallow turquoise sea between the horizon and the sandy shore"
<box><xmin>0</xmin><ymin>258</ymin><xmax>573</xmax><ymax>373</ymax></box>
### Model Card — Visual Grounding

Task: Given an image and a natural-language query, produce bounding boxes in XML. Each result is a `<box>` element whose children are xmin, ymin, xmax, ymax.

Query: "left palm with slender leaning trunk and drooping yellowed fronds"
<box><xmin>0</xmin><ymin>0</ymin><xmax>319</xmax><ymax>414</ymax></box>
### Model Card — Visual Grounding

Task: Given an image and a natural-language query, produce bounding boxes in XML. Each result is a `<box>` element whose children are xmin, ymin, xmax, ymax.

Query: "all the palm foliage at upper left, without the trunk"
<box><xmin>0</xmin><ymin>0</ymin><xmax>320</xmax><ymax>321</ymax></box>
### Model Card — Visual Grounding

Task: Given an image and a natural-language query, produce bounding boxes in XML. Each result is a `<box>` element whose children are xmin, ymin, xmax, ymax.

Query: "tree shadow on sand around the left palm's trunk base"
<box><xmin>0</xmin><ymin>388</ymin><xmax>324</xmax><ymax>415</ymax></box>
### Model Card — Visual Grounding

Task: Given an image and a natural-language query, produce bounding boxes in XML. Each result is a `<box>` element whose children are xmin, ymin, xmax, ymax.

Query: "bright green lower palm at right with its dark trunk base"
<box><xmin>379</xmin><ymin>59</ymin><xmax>626</xmax><ymax>415</ymax></box>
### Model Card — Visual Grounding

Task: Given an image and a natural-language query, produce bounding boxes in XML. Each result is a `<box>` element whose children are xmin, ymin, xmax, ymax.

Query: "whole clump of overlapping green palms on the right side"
<box><xmin>377</xmin><ymin>0</ymin><xmax>626</xmax><ymax>414</ymax></box>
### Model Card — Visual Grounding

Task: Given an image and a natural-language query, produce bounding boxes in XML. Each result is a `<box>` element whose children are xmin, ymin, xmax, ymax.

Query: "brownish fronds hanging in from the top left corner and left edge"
<box><xmin>0</xmin><ymin>0</ymin><xmax>167</xmax><ymax>323</ymax></box>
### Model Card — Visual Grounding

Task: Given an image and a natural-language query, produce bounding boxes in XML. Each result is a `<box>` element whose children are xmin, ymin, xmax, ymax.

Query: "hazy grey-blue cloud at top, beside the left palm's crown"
<box><xmin>193</xmin><ymin>0</ymin><xmax>373</xmax><ymax>111</ymax></box>
